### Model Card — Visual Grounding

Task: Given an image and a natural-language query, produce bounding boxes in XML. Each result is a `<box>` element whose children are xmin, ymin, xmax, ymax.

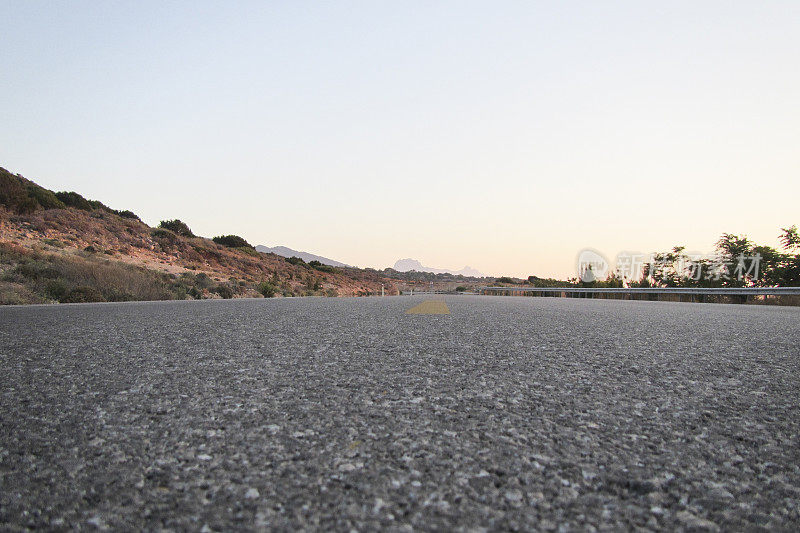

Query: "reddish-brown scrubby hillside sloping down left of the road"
<box><xmin>0</xmin><ymin>168</ymin><xmax>397</xmax><ymax>304</ymax></box>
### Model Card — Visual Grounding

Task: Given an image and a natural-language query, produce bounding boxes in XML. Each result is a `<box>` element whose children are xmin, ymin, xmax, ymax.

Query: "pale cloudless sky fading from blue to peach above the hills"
<box><xmin>0</xmin><ymin>0</ymin><xmax>800</xmax><ymax>278</ymax></box>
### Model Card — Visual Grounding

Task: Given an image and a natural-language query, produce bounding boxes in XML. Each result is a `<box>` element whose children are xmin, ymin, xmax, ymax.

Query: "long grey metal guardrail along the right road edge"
<box><xmin>479</xmin><ymin>287</ymin><xmax>800</xmax><ymax>296</ymax></box>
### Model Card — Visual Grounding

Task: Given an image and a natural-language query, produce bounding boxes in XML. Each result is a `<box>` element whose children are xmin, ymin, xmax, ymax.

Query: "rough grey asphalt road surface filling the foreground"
<box><xmin>0</xmin><ymin>296</ymin><xmax>800</xmax><ymax>531</ymax></box>
